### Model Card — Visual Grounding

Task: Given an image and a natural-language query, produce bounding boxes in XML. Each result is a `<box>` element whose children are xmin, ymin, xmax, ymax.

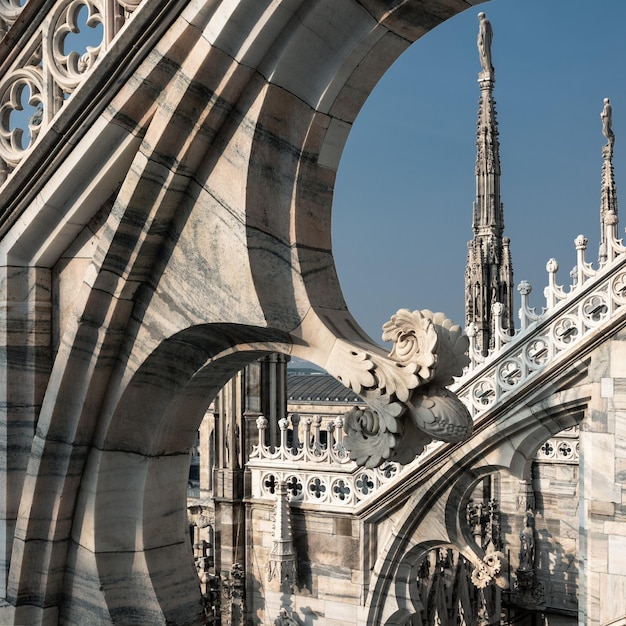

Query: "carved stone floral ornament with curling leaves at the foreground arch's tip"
<box><xmin>341</xmin><ymin>309</ymin><xmax>472</xmax><ymax>467</ymax></box>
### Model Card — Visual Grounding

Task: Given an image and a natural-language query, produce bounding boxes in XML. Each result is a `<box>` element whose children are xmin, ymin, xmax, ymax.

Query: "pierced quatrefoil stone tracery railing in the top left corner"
<box><xmin>0</xmin><ymin>0</ymin><xmax>141</xmax><ymax>185</ymax></box>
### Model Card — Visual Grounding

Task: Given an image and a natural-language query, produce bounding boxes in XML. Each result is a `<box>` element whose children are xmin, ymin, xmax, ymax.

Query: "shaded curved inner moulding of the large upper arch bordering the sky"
<box><xmin>241</xmin><ymin>2</ymin><xmax>486</xmax><ymax>336</ymax></box>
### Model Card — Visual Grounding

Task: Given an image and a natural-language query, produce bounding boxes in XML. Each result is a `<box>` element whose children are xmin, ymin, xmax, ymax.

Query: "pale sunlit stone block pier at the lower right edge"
<box><xmin>579</xmin><ymin>331</ymin><xmax>626</xmax><ymax>626</ymax></box>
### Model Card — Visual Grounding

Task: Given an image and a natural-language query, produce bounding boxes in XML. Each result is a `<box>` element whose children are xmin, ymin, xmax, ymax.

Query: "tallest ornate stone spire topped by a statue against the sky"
<box><xmin>465</xmin><ymin>13</ymin><xmax>513</xmax><ymax>353</ymax></box>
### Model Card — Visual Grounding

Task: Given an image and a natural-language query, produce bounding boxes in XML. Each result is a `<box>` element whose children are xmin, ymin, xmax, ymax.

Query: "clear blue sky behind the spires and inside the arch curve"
<box><xmin>333</xmin><ymin>0</ymin><xmax>626</xmax><ymax>341</ymax></box>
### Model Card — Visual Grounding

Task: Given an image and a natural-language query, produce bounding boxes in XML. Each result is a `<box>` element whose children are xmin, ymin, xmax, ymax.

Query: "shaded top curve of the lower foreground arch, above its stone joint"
<box><xmin>93</xmin><ymin>324</ymin><xmax>291</xmax><ymax>456</ymax></box>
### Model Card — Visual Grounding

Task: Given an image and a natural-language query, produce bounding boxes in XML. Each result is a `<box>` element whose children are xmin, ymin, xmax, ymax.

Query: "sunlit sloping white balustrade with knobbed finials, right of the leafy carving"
<box><xmin>451</xmin><ymin>215</ymin><xmax>626</xmax><ymax>419</ymax></box>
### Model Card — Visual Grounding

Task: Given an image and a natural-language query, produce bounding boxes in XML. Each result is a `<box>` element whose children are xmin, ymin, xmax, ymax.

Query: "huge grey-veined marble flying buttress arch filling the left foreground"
<box><xmin>0</xmin><ymin>0</ymin><xmax>488</xmax><ymax>624</ymax></box>
